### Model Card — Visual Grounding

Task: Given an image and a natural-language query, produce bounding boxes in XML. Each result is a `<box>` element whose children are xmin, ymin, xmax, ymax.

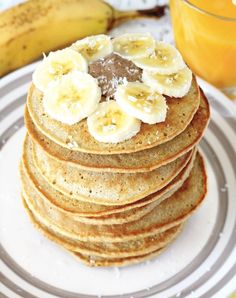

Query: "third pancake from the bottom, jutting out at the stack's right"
<box><xmin>19</xmin><ymin>154</ymin><xmax>207</xmax><ymax>243</ymax></box>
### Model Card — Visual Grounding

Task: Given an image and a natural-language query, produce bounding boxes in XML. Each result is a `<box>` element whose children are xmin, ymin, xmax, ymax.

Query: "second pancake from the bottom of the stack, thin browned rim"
<box><xmin>23</xmin><ymin>198</ymin><xmax>182</xmax><ymax>259</ymax></box>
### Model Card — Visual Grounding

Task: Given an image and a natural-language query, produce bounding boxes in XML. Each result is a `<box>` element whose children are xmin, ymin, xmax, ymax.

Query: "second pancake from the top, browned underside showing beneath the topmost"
<box><xmin>25</xmin><ymin>90</ymin><xmax>210</xmax><ymax>173</ymax></box>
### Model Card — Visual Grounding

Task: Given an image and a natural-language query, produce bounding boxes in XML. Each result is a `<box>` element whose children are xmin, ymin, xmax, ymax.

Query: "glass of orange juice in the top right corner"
<box><xmin>170</xmin><ymin>0</ymin><xmax>236</xmax><ymax>87</ymax></box>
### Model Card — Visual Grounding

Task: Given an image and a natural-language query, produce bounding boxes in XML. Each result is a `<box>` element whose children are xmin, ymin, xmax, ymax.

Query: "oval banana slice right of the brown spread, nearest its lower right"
<box><xmin>115</xmin><ymin>82</ymin><xmax>167</xmax><ymax>124</ymax></box>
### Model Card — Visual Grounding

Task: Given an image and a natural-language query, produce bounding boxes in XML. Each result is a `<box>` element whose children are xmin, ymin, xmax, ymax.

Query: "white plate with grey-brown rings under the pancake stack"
<box><xmin>0</xmin><ymin>63</ymin><xmax>236</xmax><ymax>298</ymax></box>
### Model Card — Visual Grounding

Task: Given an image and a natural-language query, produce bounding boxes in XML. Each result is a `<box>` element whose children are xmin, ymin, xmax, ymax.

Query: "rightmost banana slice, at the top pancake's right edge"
<box><xmin>142</xmin><ymin>67</ymin><xmax>192</xmax><ymax>97</ymax></box>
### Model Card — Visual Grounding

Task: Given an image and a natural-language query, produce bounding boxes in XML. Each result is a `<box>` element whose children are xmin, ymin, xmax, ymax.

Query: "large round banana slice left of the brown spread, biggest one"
<box><xmin>43</xmin><ymin>71</ymin><xmax>101</xmax><ymax>125</ymax></box>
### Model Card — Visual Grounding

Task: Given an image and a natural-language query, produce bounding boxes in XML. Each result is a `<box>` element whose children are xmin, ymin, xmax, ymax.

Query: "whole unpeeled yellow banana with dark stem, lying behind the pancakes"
<box><xmin>0</xmin><ymin>0</ymin><xmax>166</xmax><ymax>77</ymax></box>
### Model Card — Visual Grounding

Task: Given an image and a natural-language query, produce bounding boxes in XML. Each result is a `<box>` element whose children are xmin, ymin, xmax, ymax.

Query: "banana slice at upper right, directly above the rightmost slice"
<box><xmin>133</xmin><ymin>42</ymin><xmax>186</xmax><ymax>74</ymax></box>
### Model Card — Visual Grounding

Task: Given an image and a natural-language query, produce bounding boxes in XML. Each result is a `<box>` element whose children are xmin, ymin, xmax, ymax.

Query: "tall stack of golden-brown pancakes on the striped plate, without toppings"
<box><xmin>20</xmin><ymin>78</ymin><xmax>209</xmax><ymax>266</ymax></box>
